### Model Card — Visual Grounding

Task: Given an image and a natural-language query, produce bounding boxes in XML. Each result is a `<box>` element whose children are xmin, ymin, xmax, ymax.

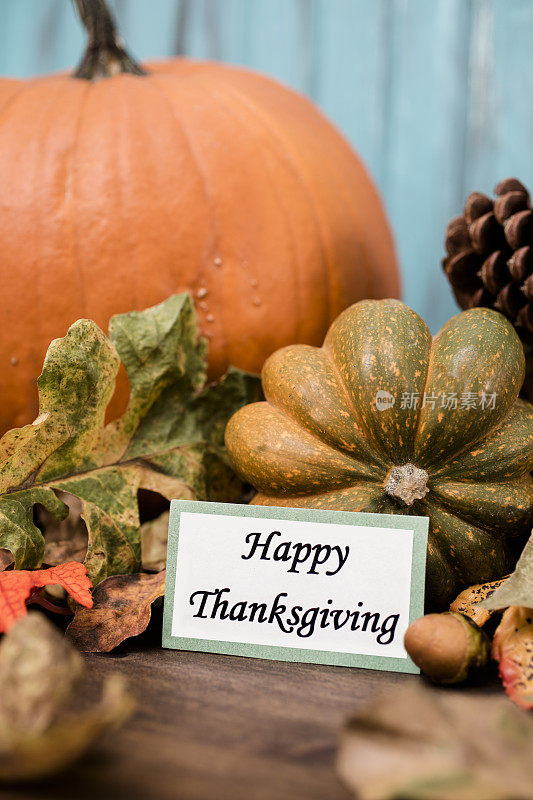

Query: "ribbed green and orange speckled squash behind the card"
<box><xmin>226</xmin><ymin>300</ymin><xmax>533</xmax><ymax>608</ymax></box>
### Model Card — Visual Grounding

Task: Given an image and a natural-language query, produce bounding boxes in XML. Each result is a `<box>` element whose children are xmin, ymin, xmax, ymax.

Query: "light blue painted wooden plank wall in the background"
<box><xmin>0</xmin><ymin>0</ymin><xmax>533</xmax><ymax>331</ymax></box>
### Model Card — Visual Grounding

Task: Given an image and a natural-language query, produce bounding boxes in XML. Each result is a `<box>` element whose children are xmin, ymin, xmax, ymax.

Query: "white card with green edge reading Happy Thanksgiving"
<box><xmin>164</xmin><ymin>502</ymin><xmax>427</xmax><ymax>671</ymax></box>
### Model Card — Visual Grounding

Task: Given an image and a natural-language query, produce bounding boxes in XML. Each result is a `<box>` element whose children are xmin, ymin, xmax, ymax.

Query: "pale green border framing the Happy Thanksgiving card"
<box><xmin>162</xmin><ymin>500</ymin><xmax>429</xmax><ymax>674</ymax></box>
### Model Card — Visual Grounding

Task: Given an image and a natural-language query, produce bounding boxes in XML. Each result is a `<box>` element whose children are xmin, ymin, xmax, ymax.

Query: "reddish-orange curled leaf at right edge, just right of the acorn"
<box><xmin>492</xmin><ymin>606</ymin><xmax>533</xmax><ymax>710</ymax></box>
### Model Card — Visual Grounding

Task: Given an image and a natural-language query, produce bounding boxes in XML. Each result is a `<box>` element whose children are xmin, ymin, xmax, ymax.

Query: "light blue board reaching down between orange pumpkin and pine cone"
<box><xmin>383</xmin><ymin>0</ymin><xmax>469</xmax><ymax>332</ymax></box>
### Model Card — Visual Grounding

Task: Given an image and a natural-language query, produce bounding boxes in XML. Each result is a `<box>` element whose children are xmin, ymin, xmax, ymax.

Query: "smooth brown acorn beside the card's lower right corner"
<box><xmin>404</xmin><ymin>611</ymin><xmax>490</xmax><ymax>683</ymax></box>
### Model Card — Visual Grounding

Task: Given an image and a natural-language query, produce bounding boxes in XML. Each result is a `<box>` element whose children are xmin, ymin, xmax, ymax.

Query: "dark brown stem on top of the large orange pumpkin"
<box><xmin>74</xmin><ymin>0</ymin><xmax>146</xmax><ymax>81</ymax></box>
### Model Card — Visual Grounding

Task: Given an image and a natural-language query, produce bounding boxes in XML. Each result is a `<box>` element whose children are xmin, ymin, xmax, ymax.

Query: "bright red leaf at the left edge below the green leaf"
<box><xmin>0</xmin><ymin>561</ymin><xmax>93</xmax><ymax>633</ymax></box>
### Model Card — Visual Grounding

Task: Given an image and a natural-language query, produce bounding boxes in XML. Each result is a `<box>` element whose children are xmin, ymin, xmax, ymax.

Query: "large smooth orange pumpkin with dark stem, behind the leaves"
<box><xmin>0</xmin><ymin>0</ymin><xmax>399</xmax><ymax>430</ymax></box>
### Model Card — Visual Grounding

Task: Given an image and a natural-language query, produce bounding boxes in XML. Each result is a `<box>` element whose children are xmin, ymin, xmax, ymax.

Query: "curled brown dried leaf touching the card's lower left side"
<box><xmin>67</xmin><ymin>570</ymin><xmax>165</xmax><ymax>653</ymax></box>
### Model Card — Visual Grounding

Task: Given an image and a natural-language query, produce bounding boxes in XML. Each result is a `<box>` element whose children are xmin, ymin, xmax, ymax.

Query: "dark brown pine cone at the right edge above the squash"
<box><xmin>442</xmin><ymin>178</ymin><xmax>533</xmax><ymax>346</ymax></box>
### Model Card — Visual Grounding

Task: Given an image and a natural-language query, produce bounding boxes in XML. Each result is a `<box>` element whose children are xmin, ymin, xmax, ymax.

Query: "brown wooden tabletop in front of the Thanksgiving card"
<box><xmin>0</xmin><ymin>632</ymin><xmax>496</xmax><ymax>800</ymax></box>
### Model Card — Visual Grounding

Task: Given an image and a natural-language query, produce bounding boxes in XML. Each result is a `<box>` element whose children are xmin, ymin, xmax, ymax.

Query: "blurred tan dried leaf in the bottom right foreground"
<box><xmin>337</xmin><ymin>684</ymin><xmax>533</xmax><ymax>800</ymax></box>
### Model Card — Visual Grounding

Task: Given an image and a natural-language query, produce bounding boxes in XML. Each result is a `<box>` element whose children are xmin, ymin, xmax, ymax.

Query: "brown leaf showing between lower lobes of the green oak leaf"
<box><xmin>38</xmin><ymin>491</ymin><xmax>88</xmax><ymax>567</ymax></box>
